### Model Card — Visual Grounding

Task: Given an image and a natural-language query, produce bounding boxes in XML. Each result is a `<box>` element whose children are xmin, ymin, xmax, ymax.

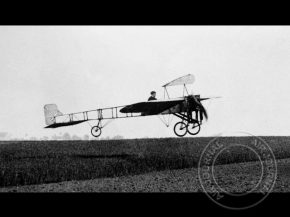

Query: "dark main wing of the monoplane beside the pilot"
<box><xmin>120</xmin><ymin>99</ymin><xmax>184</xmax><ymax>115</ymax></box>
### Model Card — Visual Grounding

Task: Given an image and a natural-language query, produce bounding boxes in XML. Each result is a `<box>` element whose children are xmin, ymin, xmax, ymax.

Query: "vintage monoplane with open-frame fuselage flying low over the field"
<box><xmin>44</xmin><ymin>74</ymin><xmax>217</xmax><ymax>137</ymax></box>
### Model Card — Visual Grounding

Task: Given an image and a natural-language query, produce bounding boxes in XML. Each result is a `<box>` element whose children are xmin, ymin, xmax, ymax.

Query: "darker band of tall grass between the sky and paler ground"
<box><xmin>0</xmin><ymin>137</ymin><xmax>290</xmax><ymax>187</ymax></box>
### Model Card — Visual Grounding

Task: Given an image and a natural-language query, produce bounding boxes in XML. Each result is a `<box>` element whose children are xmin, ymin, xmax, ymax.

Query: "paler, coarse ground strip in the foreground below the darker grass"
<box><xmin>0</xmin><ymin>158</ymin><xmax>290</xmax><ymax>193</ymax></box>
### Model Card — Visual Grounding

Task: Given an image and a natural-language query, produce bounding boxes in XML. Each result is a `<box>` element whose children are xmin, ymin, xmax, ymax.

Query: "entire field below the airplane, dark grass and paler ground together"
<box><xmin>0</xmin><ymin>137</ymin><xmax>290</xmax><ymax>191</ymax></box>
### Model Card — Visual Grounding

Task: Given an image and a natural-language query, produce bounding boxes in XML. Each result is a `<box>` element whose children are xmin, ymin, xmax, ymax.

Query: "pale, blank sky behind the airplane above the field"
<box><xmin>0</xmin><ymin>26</ymin><xmax>290</xmax><ymax>138</ymax></box>
